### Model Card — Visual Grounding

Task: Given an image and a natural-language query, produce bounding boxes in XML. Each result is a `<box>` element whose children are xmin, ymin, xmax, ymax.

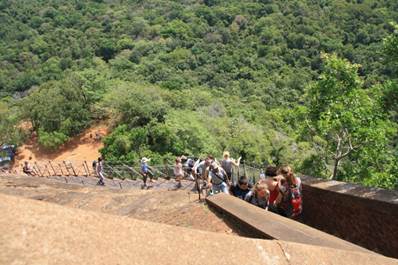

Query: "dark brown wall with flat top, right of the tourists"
<box><xmin>302</xmin><ymin>177</ymin><xmax>398</xmax><ymax>258</ymax></box>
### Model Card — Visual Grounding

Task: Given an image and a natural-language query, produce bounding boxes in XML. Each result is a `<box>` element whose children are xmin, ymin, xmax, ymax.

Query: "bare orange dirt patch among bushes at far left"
<box><xmin>14</xmin><ymin>124</ymin><xmax>108</xmax><ymax>169</ymax></box>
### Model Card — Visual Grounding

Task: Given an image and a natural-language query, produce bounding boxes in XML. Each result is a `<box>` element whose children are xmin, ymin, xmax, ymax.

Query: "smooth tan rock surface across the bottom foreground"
<box><xmin>0</xmin><ymin>194</ymin><xmax>397</xmax><ymax>265</ymax></box>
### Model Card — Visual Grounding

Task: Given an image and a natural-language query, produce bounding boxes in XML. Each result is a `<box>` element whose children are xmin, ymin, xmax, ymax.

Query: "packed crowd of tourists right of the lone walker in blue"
<box><xmin>174</xmin><ymin>152</ymin><xmax>302</xmax><ymax>217</ymax></box>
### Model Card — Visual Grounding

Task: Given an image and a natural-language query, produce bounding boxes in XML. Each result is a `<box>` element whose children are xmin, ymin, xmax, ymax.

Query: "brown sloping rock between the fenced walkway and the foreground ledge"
<box><xmin>0</xmin><ymin>176</ymin><xmax>239</xmax><ymax>234</ymax></box>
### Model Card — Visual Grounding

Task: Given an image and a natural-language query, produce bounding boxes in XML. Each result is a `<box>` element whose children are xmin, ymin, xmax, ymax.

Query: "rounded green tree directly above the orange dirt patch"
<box><xmin>20</xmin><ymin>76</ymin><xmax>90</xmax><ymax>149</ymax></box>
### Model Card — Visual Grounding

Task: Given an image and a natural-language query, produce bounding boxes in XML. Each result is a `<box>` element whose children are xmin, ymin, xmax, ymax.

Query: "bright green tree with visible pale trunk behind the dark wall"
<box><xmin>307</xmin><ymin>55</ymin><xmax>387</xmax><ymax>179</ymax></box>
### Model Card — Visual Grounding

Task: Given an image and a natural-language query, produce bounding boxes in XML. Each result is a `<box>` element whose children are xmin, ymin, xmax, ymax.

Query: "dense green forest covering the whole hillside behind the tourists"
<box><xmin>0</xmin><ymin>0</ymin><xmax>398</xmax><ymax>189</ymax></box>
